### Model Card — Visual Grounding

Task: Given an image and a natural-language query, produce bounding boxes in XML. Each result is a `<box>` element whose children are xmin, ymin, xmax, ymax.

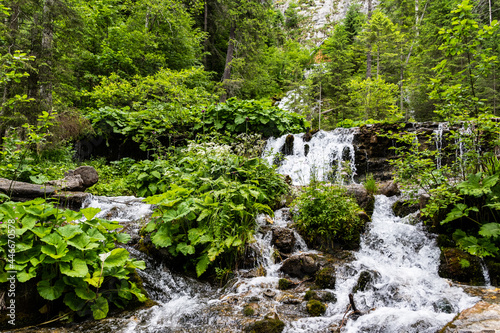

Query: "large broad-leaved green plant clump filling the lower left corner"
<box><xmin>0</xmin><ymin>199</ymin><xmax>146</xmax><ymax>319</ymax></box>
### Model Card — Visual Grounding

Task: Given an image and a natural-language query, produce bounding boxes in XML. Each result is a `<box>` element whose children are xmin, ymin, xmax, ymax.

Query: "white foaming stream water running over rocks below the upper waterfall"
<box><xmin>65</xmin><ymin>192</ymin><xmax>478</xmax><ymax>333</ymax></box>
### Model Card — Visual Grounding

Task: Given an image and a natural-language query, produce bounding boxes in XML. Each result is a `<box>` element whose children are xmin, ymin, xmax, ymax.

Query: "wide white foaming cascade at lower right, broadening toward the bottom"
<box><xmin>330</xmin><ymin>195</ymin><xmax>477</xmax><ymax>333</ymax></box>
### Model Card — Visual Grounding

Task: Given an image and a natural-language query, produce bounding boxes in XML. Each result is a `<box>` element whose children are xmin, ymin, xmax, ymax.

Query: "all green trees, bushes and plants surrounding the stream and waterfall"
<box><xmin>0</xmin><ymin>0</ymin><xmax>500</xmax><ymax>324</ymax></box>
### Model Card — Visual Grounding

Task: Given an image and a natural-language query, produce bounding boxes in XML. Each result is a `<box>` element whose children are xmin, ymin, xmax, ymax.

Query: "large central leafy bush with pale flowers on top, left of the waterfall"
<box><xmin>144</xmin><ymin>148</ymin><xmax>288</xmax><ymax>276</ymax></box>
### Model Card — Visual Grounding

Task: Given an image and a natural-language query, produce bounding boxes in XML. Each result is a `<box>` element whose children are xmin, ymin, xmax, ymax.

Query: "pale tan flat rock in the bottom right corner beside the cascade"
<box><xmin>440</xmin><ymin>301</ymin><xmax>500</xmax><ymax>333</ymax></box>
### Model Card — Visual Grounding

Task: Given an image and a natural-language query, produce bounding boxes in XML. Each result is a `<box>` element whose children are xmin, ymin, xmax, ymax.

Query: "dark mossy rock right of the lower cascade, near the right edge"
<box><xmin>439</xmin><ymin>248</ymin><xmax>484</xmax><ymax>285</ymax></box>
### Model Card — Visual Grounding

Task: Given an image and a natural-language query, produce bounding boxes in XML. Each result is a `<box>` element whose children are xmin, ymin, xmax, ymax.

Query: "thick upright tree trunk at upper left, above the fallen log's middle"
<box><xmin>39</xmin><ymin>0</ymin><xmax>54</xmax><ymax>113</ymax></box>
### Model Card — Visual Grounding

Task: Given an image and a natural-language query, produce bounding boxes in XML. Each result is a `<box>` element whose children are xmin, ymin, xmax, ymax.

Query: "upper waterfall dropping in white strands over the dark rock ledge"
<box><xmin>263</xmin><ymin>128</ymin><xmax>357</xmax><ymax>185</ymax></box>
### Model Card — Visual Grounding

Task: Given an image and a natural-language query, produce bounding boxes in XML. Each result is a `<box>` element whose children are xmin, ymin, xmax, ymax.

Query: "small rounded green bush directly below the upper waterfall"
<box><xmin>292</xmin><ymin>184</ymin><xmax>364</xmax><ymax>248</ymax></box>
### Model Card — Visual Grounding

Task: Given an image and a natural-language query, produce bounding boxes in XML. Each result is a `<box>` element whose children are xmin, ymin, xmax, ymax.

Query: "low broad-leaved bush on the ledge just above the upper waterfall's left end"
<box><xmin>194</xmin><ymin>98</ymin><xmax>308</xmax><ymax>137</ymax></box>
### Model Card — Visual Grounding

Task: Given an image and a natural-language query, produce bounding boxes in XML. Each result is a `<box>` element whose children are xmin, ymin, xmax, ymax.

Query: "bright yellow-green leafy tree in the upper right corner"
<box><xmin>429</xmin><ymin>0</ymin><xmax>499</xmax><ymax>120</ymax></box>
